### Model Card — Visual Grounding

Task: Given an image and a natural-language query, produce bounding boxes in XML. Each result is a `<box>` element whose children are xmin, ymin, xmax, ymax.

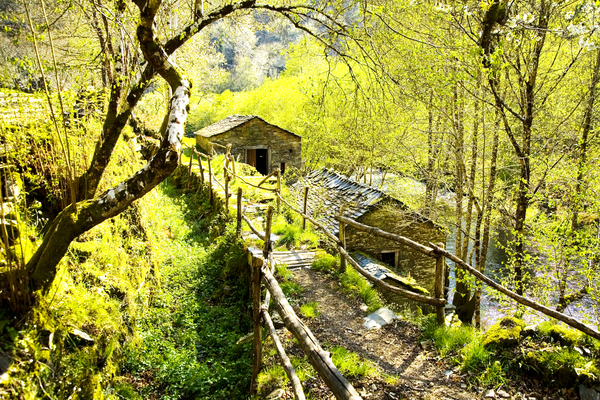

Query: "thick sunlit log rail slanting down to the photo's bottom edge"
<box><xmin>262</xmin><ymin>267</ymin><xmax>361</xmax><ymax>400</ymax></box>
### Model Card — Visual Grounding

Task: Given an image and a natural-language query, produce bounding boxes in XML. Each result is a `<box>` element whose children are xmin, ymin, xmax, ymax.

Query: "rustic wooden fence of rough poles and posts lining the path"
<box><xmin>179</xmin><ymin>145</ymin><xmax>600</xmax><ymax>399</ymax></box>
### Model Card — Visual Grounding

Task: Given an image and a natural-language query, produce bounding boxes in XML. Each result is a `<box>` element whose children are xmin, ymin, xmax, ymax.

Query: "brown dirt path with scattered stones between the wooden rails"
<box><xmin>294</xmin><ymin>269</ymin><xmax>483</xmax><ymax>400</ymax></box>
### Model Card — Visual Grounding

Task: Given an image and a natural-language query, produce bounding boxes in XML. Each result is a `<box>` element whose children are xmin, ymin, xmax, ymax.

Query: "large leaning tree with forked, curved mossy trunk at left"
<box><xmin>12</xmin><ymin>0</ymin><xmax>356</xmax><ymax>298</ymax></box>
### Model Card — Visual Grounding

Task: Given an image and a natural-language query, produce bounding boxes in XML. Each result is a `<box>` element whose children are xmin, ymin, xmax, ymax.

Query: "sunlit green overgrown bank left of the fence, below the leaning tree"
<box><xmin>0</xmin><ymin>178</ymin><xmax>251</xmax><ymax>399</ymax></box>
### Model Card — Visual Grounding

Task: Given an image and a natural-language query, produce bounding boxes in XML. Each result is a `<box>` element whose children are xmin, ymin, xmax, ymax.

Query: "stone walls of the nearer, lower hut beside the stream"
<box><xmin>345</xmin><ymin>206</ymin><xmax>446</xmax><ymax>294</ymax></box>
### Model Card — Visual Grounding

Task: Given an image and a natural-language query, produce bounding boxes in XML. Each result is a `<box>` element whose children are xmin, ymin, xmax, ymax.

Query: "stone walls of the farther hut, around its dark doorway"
<box><xmin>196</xmin><ymin>118</ymin><xmax>302</xmax><ymax>171</ymax></box>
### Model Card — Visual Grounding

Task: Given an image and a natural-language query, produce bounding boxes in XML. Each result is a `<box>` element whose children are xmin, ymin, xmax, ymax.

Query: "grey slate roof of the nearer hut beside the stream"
<box><xmin>294</xmin><ymin>168</ymin><xmax>435</xmax><ymax>236</ymax></box>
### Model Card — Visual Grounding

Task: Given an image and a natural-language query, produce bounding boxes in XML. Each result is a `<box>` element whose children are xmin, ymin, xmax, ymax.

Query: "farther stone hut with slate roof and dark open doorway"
<box><xmin>195</xmin><ymin>115</ymin><xmax>302</xmax><ymax>175</ymax></box>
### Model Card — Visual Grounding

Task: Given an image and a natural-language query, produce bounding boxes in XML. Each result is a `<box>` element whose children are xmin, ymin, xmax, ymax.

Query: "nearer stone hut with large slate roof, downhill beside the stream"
<box><xmin>295</xmin><ymin>169</ymin><xmax>446</xmax><ymax>293</ymax></box>
